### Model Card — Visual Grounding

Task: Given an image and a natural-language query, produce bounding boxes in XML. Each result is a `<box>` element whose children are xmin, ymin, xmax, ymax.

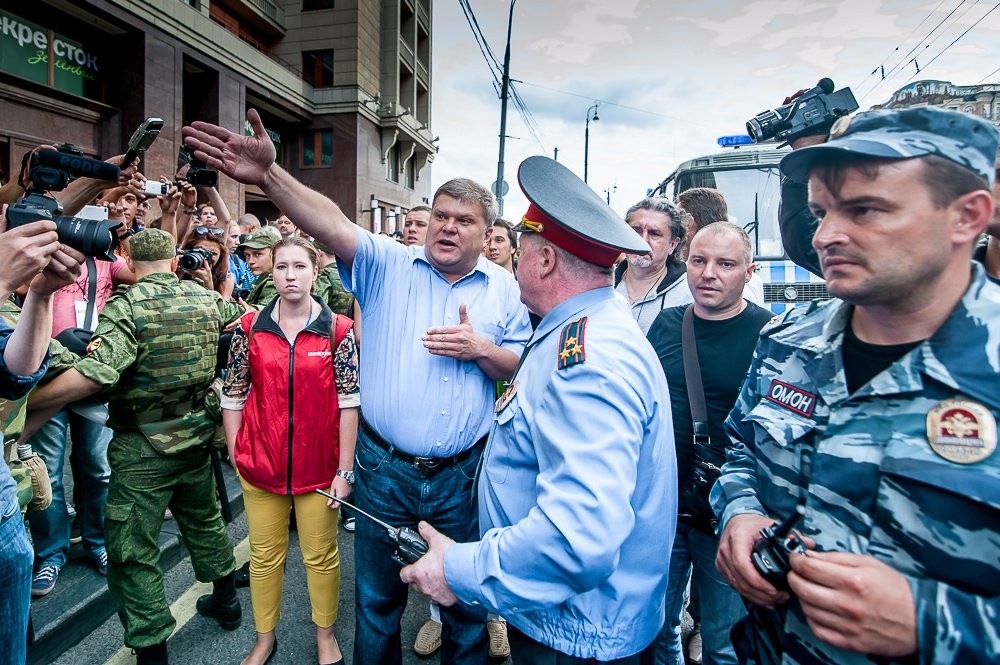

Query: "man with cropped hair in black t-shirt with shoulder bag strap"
<box><xmin>648</xmin><ymin>222</ymin><xmax>771</xmax><ymax>665</ymax></box>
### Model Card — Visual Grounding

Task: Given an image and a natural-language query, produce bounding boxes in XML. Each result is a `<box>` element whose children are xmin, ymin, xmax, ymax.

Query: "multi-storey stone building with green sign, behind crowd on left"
<box><xmin>0</xmin><ymin>0</ymin><xmax>436</xmax><ymax>231</ymax></box>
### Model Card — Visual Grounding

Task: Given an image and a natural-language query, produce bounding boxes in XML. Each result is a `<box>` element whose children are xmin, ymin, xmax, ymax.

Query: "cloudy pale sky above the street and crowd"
<box><xmin>431</xmin><ymin>0</ymin><xmax>1000</xmax><ymax>221</ymax></box>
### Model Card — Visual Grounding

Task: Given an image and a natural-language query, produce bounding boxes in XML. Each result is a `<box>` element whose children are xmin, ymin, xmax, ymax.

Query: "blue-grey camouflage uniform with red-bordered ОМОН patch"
<box><xmin>712</xmin><ymin>264</ymin><xmax>1000</xmax><ymax>665</ymax></box>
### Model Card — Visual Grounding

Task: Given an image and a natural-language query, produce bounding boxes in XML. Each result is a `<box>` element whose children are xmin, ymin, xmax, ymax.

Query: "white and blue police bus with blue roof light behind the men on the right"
<box><xmin>652</xmin><ymin>136</ymin><xmax>830</xmax><ymax>314</ymax></box>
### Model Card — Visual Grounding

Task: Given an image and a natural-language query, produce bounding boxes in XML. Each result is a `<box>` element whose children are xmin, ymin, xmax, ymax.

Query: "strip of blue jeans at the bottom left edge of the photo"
<box><xmin>0</xmin><ymin>482</ymin><xmax>31</xmax><ymax>665</ymax></box>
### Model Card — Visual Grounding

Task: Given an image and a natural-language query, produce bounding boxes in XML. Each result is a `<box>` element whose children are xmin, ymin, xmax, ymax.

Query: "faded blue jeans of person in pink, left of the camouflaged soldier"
<box><xmin>28</xmin><ymin>409</ymin><xmax>112</xmax><ymax>568</ymax></box>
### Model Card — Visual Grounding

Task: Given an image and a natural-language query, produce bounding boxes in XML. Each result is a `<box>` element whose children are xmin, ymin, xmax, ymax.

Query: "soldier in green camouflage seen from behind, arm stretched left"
<box><xmin>29</xmin><ymin>229</ymin><xmax>243</xmax><ymax>663</ymax></box>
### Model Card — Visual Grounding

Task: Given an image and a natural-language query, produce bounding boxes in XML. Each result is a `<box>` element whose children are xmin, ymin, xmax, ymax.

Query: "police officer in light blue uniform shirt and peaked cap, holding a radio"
<box><xmin>401</xmin><ymin>157</ymin><xmax>677</xmax><ymax>665</ymax></box>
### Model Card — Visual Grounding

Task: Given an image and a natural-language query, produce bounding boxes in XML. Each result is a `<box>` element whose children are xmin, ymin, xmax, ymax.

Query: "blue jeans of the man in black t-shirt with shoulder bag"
<box><xmin>656</xmin><ymin>521</ymin><xmax>746</xmax><ymax>665</ymax></box>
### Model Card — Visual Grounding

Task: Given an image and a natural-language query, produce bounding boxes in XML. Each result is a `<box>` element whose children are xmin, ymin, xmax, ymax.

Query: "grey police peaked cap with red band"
<box><xmin>514</xmin><ymin>156</ymin><xmax>650</xmax><ymax>267</ymax></box>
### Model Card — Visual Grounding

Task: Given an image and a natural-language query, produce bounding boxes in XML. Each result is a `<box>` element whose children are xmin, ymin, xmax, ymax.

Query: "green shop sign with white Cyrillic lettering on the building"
<box><xmin>0</xmin><ymin>10</ymin><xmax>101</xmax><ymax>98</ymax></box>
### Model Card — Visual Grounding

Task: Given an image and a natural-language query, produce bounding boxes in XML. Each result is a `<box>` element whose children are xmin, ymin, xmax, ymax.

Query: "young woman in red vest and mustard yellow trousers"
<box><xmin>222</xmin><ymin>237</ymin><xmax>360</xmax><ymax>665</ymax></box>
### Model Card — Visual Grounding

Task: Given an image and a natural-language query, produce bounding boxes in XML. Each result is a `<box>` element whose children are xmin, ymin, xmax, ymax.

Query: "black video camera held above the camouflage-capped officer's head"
<box><xmin>747</xmin><ymin>78</ymin><xmax>858</xmax><ymax>143</ymax></box>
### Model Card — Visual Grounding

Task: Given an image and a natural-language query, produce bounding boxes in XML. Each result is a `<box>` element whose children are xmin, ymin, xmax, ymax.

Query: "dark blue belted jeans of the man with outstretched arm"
<box><xmin>354</xmin><ymin>431</ymin><xmax>489</xmax><ymax>665</ymax></box>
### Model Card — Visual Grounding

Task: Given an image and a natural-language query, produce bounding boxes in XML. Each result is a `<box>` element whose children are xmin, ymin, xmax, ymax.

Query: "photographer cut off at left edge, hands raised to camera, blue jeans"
<box><xmin>0</xmin><ymin>213</ymin><xmax>82</xmax><ymax>663</ymax></box>
